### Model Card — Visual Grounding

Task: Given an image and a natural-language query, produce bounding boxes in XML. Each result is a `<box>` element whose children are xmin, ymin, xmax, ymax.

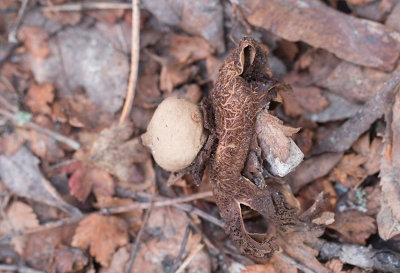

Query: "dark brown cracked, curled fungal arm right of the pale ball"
<box><xmin>210</xmin><ymin>38</ymin><xmax>296</xmax><ymax>259</ymax></box>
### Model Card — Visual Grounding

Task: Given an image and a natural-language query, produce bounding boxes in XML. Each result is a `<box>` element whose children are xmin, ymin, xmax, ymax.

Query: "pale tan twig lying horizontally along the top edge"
<box><xmin>42</xmin><ymin>2</ymin><xmax>132</xmax><ymax>12</ymax></box>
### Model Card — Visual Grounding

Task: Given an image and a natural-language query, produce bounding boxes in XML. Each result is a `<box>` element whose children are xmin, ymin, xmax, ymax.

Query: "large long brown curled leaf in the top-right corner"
<box><xmin>240</xmin><ymin>0</ymin><xmax>400</xmax><ymax>71</ymax></box>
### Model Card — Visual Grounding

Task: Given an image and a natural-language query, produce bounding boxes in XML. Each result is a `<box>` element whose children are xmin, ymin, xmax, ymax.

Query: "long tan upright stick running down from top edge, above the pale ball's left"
<box><xmin>119</xmin><ymin>0</ymin><xmax>140</xmax><ymax>123</ymax></box>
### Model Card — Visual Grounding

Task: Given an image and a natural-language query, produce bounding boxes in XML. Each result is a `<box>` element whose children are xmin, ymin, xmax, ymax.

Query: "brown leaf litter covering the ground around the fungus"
<box><xmin>0</xmin><ymin>0</ymin><xmax>400</xmax><ymax>272</ymax></box>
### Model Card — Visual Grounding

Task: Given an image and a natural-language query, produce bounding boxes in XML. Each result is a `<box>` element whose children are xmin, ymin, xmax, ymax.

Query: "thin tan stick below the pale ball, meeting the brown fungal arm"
<box><xmin>104</xmin><ymin>191</ymin><xmax>212</xmax><ymax>214</ymax></box>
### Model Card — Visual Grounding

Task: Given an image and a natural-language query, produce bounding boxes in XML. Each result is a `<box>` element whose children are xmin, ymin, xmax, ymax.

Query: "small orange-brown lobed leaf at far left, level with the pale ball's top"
<box><xmin>25</xmin><ymin>83</ymin><xmax>54</xmax><ymax>115</ymax></box>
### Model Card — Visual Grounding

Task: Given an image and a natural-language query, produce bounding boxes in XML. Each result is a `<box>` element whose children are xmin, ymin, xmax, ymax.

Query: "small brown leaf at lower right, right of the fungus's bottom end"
<box><xmin>328</xmin><ymin>210</ymin><xmax>377</xmax><ymax>245</ymax></box>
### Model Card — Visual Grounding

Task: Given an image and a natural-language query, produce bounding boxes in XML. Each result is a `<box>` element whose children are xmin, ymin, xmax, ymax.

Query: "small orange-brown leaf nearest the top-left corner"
<box><xmin>18</xmin><ymin>25</ymin><xmax>50</xmax><ymax>59</ymax></box>
